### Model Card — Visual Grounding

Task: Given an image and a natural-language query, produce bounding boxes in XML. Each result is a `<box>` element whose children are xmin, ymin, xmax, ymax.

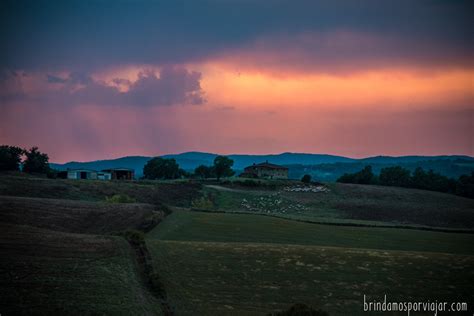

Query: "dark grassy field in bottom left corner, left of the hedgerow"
<box><xmin>0</xmin><ymin>224</ymin><xmax>160</xmax><ymax>315</ymax></box>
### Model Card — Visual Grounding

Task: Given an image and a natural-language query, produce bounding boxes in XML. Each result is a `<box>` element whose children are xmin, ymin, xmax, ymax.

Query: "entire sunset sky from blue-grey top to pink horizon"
<box><xmin>0</xmin><ymin>0</ymin><xmax>474</xmax><ymax>162</ymax></box>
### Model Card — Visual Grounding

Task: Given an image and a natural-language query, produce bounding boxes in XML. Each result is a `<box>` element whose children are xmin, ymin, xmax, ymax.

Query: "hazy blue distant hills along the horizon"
<box><xmin>50</xmin><ymin>152</ymin><xmax>474</xmax><ymax>181</ymax></box>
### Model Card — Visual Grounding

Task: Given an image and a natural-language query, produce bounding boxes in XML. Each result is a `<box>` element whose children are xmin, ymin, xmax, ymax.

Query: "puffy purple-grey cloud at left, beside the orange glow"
<box><xmin>8</xmin><ymin>66</ymin><xmax>205</xmax><ymax>106</ymax></box>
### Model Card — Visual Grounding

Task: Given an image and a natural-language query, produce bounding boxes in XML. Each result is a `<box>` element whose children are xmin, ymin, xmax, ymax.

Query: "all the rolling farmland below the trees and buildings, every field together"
<box><xmin>0</xmin><ymin>174</ymin><xmax>474</xmax><ymax>315</ymax></box>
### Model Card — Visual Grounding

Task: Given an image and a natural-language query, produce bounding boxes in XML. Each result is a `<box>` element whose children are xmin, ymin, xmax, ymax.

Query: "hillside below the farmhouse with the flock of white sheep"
<box><xmin>206</xmin><ymin>181</ymin><xmax>474</xmax><ymax>229</ymax></box>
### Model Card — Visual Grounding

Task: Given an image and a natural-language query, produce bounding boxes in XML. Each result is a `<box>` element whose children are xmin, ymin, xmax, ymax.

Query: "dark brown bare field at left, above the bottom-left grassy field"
<box><xmin>0</xmin><ymin>196</ymin><xmax>164</xmax><ymax>234</ymax></box>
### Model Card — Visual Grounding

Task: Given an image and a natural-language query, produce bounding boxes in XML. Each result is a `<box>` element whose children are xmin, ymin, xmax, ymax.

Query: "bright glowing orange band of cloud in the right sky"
<box><xmin>202</xmin><ymin>64</ymin><xmax>474</xmax><ymax>109</ymax></box>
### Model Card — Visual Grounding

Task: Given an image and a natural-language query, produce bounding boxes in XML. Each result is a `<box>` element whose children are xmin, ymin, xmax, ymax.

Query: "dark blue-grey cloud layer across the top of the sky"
<box><xmin>0</xmin><ymin>0</ymin><xmax>474</xmax><ymax>71</ymax></box>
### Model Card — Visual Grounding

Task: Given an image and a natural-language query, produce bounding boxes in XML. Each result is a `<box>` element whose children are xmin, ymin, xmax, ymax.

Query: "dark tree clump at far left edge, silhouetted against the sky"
<box><xmin>0</xmin><ymin>145</ymin><xmax>51</xmax><ymax>174</ymax></box>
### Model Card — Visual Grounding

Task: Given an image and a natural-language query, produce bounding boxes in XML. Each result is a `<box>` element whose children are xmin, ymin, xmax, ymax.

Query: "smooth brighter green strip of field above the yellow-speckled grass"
<box><xmin>148</xmin><ymin>211</ymin><xmax>474</xmax><ymax>254</ymax></box>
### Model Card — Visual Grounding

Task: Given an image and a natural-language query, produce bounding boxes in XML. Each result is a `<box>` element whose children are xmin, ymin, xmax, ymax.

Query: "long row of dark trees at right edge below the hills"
<box><xmin>337</xmin><ymin>166</ymin><xmax>474</xmax><ymax>198</ymax></box>
